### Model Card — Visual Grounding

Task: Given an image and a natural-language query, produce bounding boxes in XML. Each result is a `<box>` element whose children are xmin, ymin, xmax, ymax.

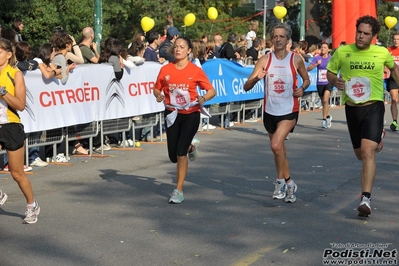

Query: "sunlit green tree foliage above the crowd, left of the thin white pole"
<box><xmin>0</xmin><ymin>0</ymin><xmax>254</xmax><ymax>46</ymax></box>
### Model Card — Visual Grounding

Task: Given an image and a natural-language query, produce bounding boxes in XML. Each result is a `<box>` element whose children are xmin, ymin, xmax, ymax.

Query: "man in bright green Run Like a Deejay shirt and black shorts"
<box><xmin>327</xmin><ymin>16</ymin><xmax>399</xmax><ymax>217</ymax></box>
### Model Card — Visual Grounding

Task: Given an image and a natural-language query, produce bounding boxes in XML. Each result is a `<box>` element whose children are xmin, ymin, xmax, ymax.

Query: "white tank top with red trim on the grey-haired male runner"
<box><xmin>264</xmin><ymin>52</ymin><xmax>299</xmax><ymax>116</ymax></box>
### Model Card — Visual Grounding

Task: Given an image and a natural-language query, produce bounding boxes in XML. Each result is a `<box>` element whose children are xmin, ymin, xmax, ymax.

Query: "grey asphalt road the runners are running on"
<box><xmin>0</xmin><ymin>105</ymin><xmax>399</xmax><ymax>266</ymax></box>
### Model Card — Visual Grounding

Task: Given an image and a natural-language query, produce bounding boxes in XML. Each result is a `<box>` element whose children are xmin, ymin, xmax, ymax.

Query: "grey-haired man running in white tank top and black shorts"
<box><xmin>244</xmin><ymin>23</ymin><xmax>310</xmax><ymax>202</ymax></box>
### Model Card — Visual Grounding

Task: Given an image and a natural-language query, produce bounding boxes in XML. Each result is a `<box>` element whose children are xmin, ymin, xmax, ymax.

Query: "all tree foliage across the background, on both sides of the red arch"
<box><xmin>0</xmin><ymin>0</ymin><xmax>399</xmax><ymax>47</ymax></box>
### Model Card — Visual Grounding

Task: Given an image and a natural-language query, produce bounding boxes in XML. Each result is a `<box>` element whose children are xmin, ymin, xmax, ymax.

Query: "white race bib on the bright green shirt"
<box><xmin>345</xmin><ymin>77</ymin><xmax>371</xmax><ymax>103</ymax></box>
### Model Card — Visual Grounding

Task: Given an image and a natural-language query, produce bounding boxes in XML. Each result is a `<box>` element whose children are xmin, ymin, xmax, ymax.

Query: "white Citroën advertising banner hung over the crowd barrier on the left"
<box><xmin>19</xmin><ymin>62</ymin><xmax>164</xmax><ymax>132</ymax></box>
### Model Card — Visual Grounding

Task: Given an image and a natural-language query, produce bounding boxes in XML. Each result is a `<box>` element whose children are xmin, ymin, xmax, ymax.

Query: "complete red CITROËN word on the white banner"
<box><xmin>39</xmin><ymin>83</ymin><xmax>100</xmax><ymax>107</ymax></box>
